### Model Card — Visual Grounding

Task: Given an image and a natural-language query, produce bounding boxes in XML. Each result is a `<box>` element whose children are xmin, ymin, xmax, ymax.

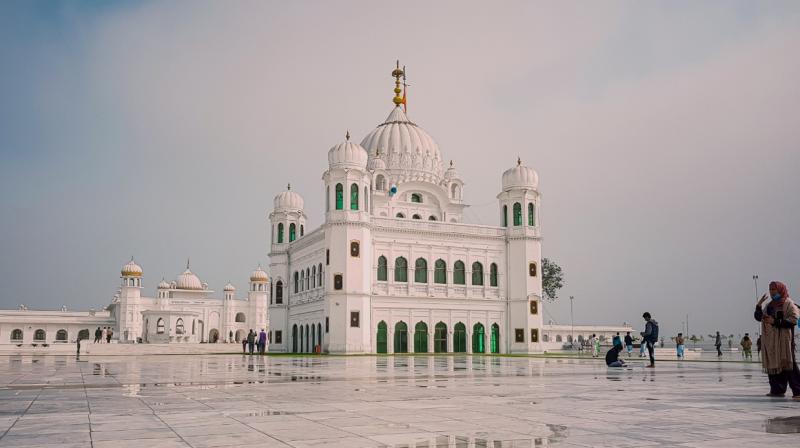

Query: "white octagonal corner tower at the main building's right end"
<box><xmin>497</xmin><ymin>159</ymin><xmax>543</xmax><ymax>353</ymax></box>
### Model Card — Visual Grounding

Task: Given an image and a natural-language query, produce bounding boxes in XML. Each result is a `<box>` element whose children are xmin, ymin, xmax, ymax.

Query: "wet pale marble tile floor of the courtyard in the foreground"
<box><xmin>0</xmin><ymin>354</ymin><xmax>800</xmax><ymax>448</ymax></box>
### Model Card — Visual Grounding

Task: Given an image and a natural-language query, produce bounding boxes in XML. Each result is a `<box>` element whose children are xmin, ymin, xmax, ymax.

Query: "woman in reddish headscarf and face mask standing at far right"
<box><xmin>755</xmin><ymin>282</ymin><xmax>800</xmax><ymax>401</ymax></box>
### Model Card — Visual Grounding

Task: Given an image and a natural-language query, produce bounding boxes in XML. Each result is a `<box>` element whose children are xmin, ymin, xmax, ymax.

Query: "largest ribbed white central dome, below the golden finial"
<box><xmin>361</xmin><ymin>106</ymin><xmax>443</xmax><ymax>184</ymax></box>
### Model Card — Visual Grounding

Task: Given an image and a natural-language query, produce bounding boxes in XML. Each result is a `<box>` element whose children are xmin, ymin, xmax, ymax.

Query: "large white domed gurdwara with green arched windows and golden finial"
<box><xmin>269</xmin><ymin>68</ymin><xmax>544</xmax><ymax>353</ymax></box>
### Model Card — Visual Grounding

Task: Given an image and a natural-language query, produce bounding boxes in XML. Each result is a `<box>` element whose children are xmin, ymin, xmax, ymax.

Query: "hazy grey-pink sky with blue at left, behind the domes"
<box><xmin>0</xmin><ymin>0</ymin><xmax>800</xmax><ymax>334</ymax></box>
